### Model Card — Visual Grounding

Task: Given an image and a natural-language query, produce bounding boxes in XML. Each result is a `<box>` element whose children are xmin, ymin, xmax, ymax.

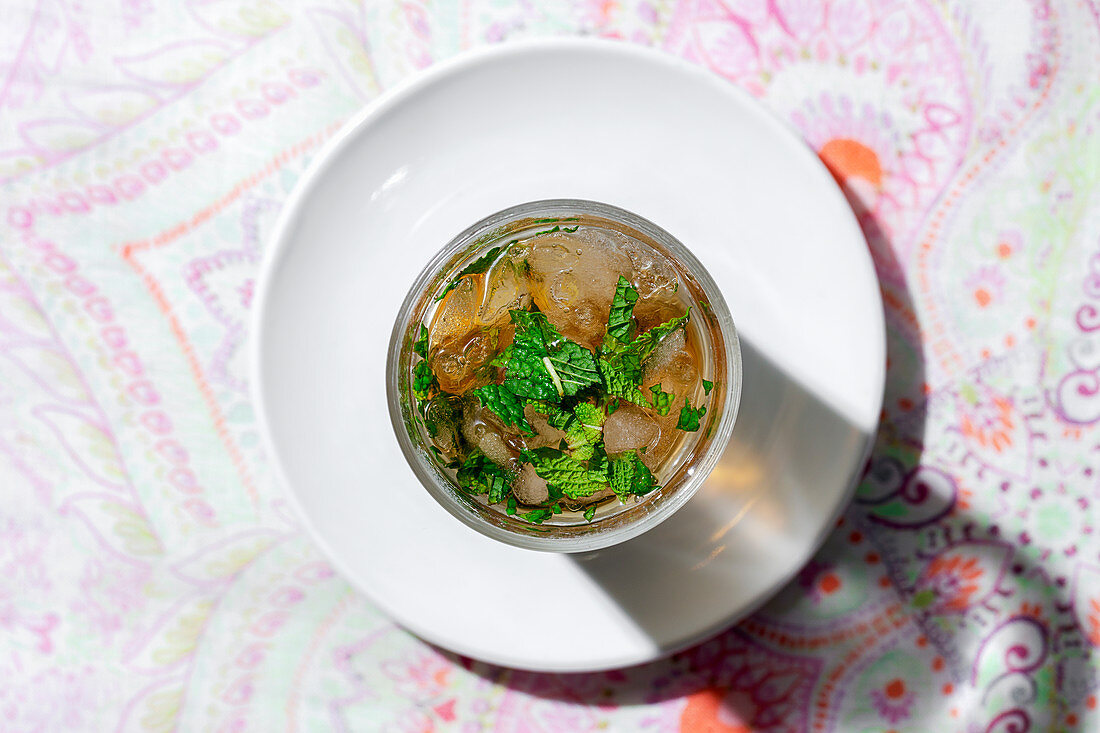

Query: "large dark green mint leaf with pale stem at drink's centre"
<box><xmin>504</xmin><ymin>310</ymin><xmax>600</xmax><ymax>402</ymax></box>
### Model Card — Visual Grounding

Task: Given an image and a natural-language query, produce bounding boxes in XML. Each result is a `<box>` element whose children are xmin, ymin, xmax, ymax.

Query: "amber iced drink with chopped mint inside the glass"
<box><xmin>402</xmin><ymin>205</ymin><xmax>725</xmax><ymax>526</ymax></box>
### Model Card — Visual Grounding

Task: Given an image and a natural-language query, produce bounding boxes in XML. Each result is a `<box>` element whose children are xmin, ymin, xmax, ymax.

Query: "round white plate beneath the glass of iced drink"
<box><xmin>253</xmin><ymin>40</ymin><xmax>886</xmax><ymax>671</ymax></box>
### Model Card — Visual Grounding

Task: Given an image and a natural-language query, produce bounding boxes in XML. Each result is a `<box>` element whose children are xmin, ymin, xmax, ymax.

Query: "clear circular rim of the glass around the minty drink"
<box><xmin>386</xmin><ymin>198</ymin><xmax>743</xmax><ymax>553</ymax></box>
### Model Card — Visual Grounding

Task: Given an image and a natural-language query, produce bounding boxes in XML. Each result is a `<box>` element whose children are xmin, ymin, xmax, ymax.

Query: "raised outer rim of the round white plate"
<box><xmin>249</xmin><ymin>36</ymin><xmax>887</xmax><ymax>672</ymax></box>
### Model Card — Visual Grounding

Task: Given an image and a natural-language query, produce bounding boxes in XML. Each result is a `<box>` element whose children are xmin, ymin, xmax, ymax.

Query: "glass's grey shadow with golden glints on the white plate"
<box><xmin>572</xmin><ymin>338</ymin><xmax>870</xmax><ymax>652</ymax></box>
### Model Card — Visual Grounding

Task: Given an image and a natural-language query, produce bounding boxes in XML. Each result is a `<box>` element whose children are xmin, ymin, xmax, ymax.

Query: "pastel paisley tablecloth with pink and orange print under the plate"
<box><xmin>0</xmin><ymin>0</ymin><xmax>1100</xmax><ymax>733</ymax></box>
